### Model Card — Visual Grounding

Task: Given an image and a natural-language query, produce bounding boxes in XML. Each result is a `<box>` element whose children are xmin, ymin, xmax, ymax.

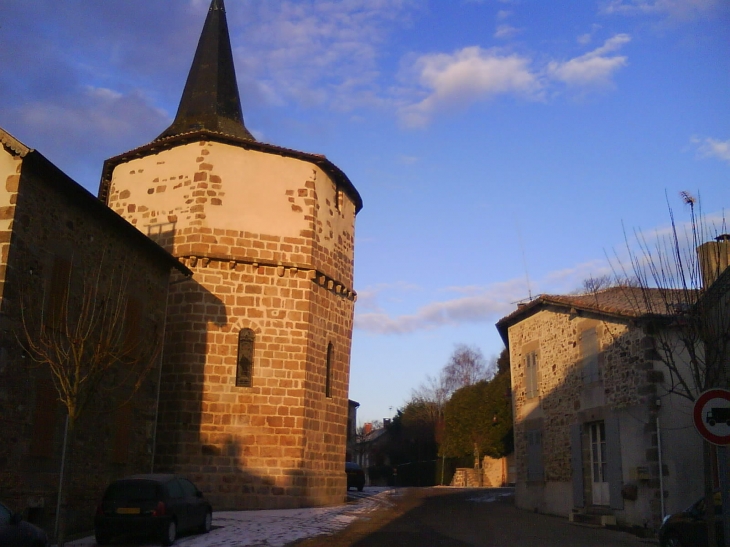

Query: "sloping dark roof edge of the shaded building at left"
<box><xmin>0</xmin><ymin>128</ymin><xmax>192</xmax><ymax>276</ymax></box>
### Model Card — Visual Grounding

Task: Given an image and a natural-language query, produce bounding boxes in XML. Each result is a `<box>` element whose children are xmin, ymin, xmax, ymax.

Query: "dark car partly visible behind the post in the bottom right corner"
<box><xmin>659</xmin><ymin>492</ymin><xmax>725</xmax><ymax>547</ymax></box>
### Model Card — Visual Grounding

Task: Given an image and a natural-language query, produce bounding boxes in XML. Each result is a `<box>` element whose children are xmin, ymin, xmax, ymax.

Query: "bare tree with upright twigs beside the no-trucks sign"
<box><xmin>614</xmin><ymin>192</ymin><xmax>730</xmax><ymax>547</ymax></box>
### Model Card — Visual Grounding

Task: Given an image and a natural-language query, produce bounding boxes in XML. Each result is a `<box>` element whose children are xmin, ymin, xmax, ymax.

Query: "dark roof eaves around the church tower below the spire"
<box><xmin>99</xmin><ymin>129</ymin><xmax>363</xmax><ymax>213</ymax></box>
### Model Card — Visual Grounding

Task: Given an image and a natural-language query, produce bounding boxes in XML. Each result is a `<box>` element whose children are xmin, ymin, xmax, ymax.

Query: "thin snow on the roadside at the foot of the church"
<box><xmin>66</xmin><ymin>487</ymin><xmax>397</xmax><ymax>547</ymax></box>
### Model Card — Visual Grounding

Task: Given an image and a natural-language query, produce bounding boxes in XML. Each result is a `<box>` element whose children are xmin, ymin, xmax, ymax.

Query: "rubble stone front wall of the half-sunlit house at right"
<box><xmin>509</xmin><ymin>309</ymin><xmax>646</xmax><ymax>481</ymax></box>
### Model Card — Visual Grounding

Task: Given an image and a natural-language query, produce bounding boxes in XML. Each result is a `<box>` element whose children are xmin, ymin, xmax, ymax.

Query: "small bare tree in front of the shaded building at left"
<box><xmin>18</xmin><ymin>259</ymin><xmax>161</xmax><ymax>546</ymax></box>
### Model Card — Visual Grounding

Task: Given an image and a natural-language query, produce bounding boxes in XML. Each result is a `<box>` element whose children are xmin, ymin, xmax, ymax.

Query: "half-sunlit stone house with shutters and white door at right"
<box><xmin>497</xmin><ymin>287</ymin><xmax>703</xmax><ymax>527</ymax></box>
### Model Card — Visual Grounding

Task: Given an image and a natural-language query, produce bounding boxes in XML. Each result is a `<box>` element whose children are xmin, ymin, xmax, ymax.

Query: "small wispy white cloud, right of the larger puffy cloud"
<box><xmin>547</xmin><ymin>34</ymin><xmax>631</xmax><ymax>86</ymax></box>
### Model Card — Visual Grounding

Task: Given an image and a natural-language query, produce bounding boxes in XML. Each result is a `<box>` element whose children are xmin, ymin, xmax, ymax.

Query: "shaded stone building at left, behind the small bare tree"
<box><xmin>0</xmin><ymin>129</ymin><xmax>190</xmax><ymax>530</ymax></box>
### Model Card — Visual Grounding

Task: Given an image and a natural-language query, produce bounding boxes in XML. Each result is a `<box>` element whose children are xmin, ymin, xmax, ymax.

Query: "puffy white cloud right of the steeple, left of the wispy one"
<box><xmin>399</xmin><ymin>46</ymin><xmax>540</xmax><ymax>127</ymax></box>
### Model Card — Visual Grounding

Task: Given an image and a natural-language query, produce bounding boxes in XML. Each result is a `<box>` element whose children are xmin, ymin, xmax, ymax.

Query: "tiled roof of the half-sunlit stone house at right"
<box><xmin>497</xmin><ymin>287</ymin><xmax>697</xmax><ymax>344</ymax></box>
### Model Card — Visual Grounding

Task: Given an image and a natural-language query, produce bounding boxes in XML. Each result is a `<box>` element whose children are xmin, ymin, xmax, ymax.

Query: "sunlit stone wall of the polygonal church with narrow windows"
<box><xmin>109</xmin><ymin>137</ymin><xmax>355</xmax><ymax>509</ymax></box>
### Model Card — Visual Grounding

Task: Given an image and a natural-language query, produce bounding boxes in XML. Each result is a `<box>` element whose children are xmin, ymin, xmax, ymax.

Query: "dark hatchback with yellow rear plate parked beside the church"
<box><xmin>94</xmin><ymin>475</ymin><xmax>213</xmax><ymax>545</ymax></box>
